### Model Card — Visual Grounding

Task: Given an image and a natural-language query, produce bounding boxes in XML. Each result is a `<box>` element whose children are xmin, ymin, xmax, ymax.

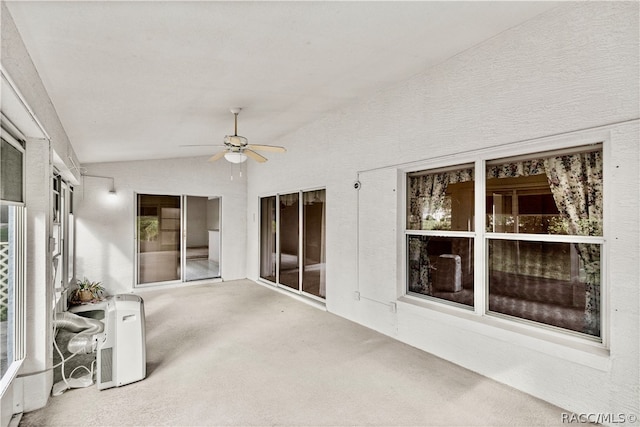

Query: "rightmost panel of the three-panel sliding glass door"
<box><xmin>302</xmin><ymin>190</ymin><xmax>326</xmax><ymax>298</ymax></box>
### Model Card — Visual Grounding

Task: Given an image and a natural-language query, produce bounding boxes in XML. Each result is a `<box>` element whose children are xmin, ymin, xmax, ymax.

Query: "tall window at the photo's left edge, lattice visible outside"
<box><xmin>0</xmin><ymin>133</ymin><xmax>26</xmax><ymax>392</ymax></box>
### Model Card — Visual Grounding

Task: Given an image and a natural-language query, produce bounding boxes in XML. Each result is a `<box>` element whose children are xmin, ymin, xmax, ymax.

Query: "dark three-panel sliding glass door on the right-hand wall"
<box><xmin>260</xmin><ymin>189</ymin><xmax>326</xmax><ymax>298</ymax></box>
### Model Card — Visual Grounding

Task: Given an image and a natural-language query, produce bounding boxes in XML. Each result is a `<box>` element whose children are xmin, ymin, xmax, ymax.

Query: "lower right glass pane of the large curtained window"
<box><xmin>489</xmin><ymin>240</ymin><xmax>600</xmax><ymax>336</ymax></box>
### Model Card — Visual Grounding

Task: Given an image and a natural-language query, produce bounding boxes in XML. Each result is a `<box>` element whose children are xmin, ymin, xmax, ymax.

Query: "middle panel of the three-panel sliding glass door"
<box><xmin>279</xmin><ymin>193</ymin><xmax>300</xmax><ymax>290</ymax></box>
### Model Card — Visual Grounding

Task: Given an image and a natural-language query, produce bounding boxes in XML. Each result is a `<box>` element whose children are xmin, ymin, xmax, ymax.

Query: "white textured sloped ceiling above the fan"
<box><xmin>6</xmin><ymin>1</ymin><xmax>556</xmax><ymax>163</ymax></box>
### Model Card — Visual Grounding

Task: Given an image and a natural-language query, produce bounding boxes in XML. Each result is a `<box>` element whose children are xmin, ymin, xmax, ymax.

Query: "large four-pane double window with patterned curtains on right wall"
<box><xmin>406</xmin><ymin>145</ymin><xmax>604</xmax><ymax>338</ymax></box>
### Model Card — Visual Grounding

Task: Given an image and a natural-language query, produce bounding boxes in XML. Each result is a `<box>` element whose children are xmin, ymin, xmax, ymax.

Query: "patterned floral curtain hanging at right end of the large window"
<box><xmin>544</xmin><ymin>151</ymin><xmax>603</xmax><ymax>336</ymax></box>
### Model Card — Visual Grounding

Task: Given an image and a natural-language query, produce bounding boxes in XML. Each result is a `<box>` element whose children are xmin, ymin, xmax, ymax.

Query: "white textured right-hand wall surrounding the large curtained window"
<box><xmin>247</xmin><ymin>2</ymin><xmax>640</xmax><ymax>422</ymax></box>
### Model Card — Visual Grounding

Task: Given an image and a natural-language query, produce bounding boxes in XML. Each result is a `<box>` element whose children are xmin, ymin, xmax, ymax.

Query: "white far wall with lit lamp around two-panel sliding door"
<box><xmin>74</xmin><ymin>157</ymin><xmax>247</xmax><ymax>295</ymax></box>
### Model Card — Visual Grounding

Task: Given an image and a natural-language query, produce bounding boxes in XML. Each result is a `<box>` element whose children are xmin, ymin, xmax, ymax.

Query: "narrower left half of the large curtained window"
<box><xmin>407</xmin><ymin>166</ymin><xmax>474</xmax><ymax>307</ymax></box>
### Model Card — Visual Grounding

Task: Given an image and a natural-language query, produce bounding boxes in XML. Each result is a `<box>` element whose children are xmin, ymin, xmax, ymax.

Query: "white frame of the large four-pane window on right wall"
<box><xmin>398</xmin><ymin>130</ymin><xmax>610</xmax><ymax>351</ymax></box>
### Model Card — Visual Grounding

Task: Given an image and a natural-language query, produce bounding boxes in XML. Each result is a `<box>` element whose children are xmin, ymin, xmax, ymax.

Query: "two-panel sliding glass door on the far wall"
<box><xmin>136</xmin><ymin>194</ymin><xmax>221</xmax><ymax>285</ymax></box>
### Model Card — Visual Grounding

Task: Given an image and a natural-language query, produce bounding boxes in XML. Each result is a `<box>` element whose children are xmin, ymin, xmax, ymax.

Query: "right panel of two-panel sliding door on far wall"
<box><xmin>184</xmin><ymin>196</ymin><xmax>220</xmax><ymax>282</ymax></box>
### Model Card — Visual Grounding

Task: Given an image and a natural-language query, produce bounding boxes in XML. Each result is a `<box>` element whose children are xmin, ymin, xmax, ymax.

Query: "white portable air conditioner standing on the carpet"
<box><xmin>97</xmin><ymin>294</ymin><xmax>147</xmax><ymax>390</ymax></box>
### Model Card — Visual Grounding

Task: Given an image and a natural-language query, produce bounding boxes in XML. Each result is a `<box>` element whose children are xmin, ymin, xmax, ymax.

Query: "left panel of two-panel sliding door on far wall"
<box><xmin>137</xmin><ymin>194</ymin><xmax>181</xmax><ymax>284</ymax></box>
